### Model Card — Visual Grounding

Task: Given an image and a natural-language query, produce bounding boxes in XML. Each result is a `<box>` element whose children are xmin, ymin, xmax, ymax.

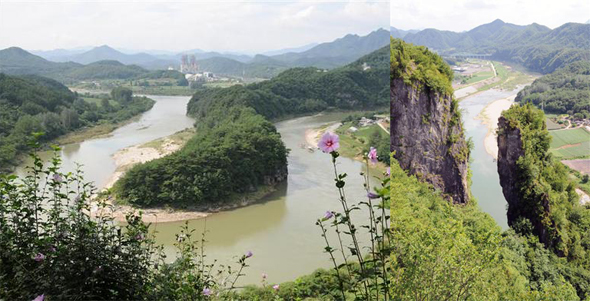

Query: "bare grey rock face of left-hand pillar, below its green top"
<box><xmin>390</xmin><ymin>78</ymin><xmax>469</xmax><ymax>204</ymax></box>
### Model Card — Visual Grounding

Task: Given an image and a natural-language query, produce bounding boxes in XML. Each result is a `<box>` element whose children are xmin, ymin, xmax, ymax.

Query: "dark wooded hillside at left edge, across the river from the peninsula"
<box><xmin>0</xmin><ymin>73</ymin><xmax>154</xmax><ymax>171</ymax></box>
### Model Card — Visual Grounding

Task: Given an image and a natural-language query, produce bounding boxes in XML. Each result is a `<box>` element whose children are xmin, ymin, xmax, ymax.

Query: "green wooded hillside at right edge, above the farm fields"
<box><xmin>516</xmin><ymin>61</ymin><xmax>590</xmax><ymax>118</ymax></box>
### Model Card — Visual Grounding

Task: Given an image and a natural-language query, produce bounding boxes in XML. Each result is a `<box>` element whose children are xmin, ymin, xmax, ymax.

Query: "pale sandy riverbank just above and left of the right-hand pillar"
<box><xmin>477</xmin><ymin>95</ymin><xmax>516</xmax><ymax>159</ymax></box>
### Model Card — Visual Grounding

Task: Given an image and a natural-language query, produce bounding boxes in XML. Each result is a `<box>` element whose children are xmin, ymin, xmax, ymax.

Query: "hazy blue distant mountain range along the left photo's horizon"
<box><xmin>0</xmin><ymin>29</ymin><xmax>389</xmax><ymax>78</ymax></box>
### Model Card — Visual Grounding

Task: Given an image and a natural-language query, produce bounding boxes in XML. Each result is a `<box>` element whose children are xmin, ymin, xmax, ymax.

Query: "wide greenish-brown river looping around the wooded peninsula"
<box><xmin>17</xmin><ymin>96</ymin><xmax>378</xmax><ymax>284</ymax></box>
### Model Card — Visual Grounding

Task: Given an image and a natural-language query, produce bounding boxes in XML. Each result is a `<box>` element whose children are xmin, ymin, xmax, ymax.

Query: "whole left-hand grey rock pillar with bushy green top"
<box><xmin>390</xmin><ymin>39</ymin><xmax>470</xmax><ymax>204</ymax></box>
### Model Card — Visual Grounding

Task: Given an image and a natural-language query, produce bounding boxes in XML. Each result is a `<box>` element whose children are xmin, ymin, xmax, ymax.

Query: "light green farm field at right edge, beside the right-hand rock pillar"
<box><xmin>549</xmin><ymin>128</ymin><xmax>590</xmax><ymax>159</ymax></box>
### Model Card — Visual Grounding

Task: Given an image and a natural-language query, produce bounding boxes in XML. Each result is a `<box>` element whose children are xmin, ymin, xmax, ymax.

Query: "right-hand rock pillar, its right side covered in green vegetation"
<box><xmin>498</xmin><ymin>103</ymin><xmax>590</xmax><ymax>297</ymax></box>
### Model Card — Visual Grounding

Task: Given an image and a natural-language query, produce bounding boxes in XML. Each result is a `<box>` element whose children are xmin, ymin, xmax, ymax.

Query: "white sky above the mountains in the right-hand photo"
<box><xmin>390</xmin><ymin>0</ymin><xmax>590</xmax><ymax>32</ymax></box>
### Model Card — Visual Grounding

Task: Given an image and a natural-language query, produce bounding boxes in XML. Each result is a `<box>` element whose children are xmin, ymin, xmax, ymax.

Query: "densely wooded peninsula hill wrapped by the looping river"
<box><xmin>114</xmin><ymin>47</ymin><xmax>389</xmax><ymax>210</ymax></box>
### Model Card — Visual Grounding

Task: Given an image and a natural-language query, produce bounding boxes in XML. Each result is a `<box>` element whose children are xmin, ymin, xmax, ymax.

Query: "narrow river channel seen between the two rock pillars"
<box><xmin>459</xmin><ymin>87</ymin><xmax>522</xmax><ymax>229</ymax></box>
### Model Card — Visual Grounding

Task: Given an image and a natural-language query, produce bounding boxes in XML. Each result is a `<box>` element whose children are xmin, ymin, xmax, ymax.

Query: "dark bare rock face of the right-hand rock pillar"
<box><xmin>498</xmin><ymin>116</ymin><xmax>562</xmax><ymax>250</ymax></box>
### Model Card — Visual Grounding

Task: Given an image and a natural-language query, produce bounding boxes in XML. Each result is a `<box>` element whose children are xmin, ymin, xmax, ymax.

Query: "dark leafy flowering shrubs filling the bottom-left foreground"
<box><xmin>0</xmin><ymin>149</ymin><xmax>252</xmax><ymax>300</ymax></box>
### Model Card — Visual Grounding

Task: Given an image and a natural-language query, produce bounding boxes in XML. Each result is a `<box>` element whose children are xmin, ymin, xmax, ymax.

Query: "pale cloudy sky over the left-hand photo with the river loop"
<box><xmin>0</xmin><ymin>0</ymin><xmax>389</xmax><ymax>53</ymax></box>
